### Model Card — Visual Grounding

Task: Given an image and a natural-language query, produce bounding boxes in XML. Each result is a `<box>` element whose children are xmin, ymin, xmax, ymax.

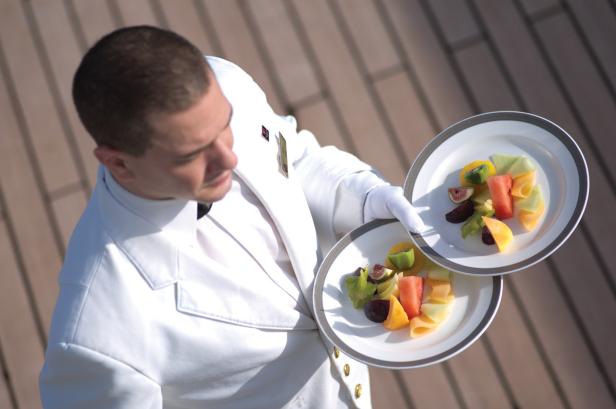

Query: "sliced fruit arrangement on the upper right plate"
<box><xmin>445</xmin><ymin>154</ymin><xmax>544</xmax><ymax>252</ymax></box>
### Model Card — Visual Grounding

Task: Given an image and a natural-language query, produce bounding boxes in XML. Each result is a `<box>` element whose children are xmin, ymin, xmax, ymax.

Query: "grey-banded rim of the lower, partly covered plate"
<box><xmin>312</xmin><ymin>219</ymin><xmax>504</xmax><ymax>369</ymax></box>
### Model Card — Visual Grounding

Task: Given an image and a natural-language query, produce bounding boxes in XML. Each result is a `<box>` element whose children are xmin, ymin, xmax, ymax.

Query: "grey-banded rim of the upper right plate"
<box><xmin>403</xmin><ymin>111</ymin><xmax>590</xmax><ymax>276</ymax></box>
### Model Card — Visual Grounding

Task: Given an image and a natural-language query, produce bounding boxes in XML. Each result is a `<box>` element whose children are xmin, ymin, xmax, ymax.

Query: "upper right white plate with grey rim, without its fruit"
<box><xmin>404</xmin><ymin>111</ymin><xmax>588</xmax><ymax>275</ymax></box>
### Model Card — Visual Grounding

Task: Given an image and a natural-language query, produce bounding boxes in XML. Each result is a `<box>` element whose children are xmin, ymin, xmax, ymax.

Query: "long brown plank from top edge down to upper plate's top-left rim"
<box><xmin>377</xmin><ymin>0</ymin><xmax>472</xmax><ymax>129</ymax></box>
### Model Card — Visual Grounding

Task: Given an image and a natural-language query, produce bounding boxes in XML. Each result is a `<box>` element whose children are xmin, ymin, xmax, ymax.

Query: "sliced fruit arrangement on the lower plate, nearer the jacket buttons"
<box><xmin>345</xmin><ymin>242</ymin><xmax>454</xmax><ymax>338</ymax></box>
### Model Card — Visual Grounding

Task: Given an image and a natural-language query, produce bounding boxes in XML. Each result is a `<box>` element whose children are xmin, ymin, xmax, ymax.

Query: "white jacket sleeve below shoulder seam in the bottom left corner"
<box><xmin>39</xmin><ymin>343</ymin><xmax>162</xmax><ymax>409</ymax></box>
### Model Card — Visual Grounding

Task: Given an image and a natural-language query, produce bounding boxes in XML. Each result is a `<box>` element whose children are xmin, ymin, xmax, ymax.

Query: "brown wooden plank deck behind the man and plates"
<box><xmin>0</xmin><ymin>0</ymin><xmax>616</xmax><ymax>409</ymax></box>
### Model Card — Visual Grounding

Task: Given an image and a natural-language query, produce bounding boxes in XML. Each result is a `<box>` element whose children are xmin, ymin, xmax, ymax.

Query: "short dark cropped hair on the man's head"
<box><xmin>73</xmin><ymin>26</ymin><xmax>210</xmax><ymax>156</ymax></box>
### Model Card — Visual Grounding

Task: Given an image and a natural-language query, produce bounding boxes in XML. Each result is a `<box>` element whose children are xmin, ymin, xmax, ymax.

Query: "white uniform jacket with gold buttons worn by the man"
<box><xmin>40</xmin><ymin>57</ymin><xmax>382</xmax><ymax>409</ymax></box>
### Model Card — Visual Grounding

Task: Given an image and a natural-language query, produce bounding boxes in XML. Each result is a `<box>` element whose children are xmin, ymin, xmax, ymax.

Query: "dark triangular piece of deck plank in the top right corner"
<box><xmin>567</xmin><ymin>0</ymin><xmax>616</xmax><ymax>90</ymax></box>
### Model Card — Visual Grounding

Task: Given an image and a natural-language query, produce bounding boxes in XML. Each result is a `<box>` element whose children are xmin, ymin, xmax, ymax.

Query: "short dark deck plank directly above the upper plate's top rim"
<box><xmin>455</xmin><ymin>42</ymin><xmax>517</xmax><ymax>112</ymax></box>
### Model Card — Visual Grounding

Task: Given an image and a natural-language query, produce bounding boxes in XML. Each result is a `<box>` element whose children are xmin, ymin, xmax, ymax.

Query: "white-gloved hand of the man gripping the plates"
<box><xmin>364</xmin><ymin>185</ymin><xmax>426</xmax><ymax>233</ymax></box>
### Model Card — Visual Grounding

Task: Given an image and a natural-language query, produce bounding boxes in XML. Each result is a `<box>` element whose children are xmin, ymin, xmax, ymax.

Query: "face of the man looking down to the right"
<box><xmin>120</xmin><ymin>72</ymin><xmax>237</xmax><ymax>203</ymax></box>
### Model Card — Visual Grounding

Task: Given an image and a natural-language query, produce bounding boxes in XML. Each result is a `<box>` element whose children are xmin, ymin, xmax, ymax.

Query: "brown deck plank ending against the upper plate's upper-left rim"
<box><xmin>374</xmin><ymin>71</ymin><xmax>437</xmax><ymax>168</ymax></box>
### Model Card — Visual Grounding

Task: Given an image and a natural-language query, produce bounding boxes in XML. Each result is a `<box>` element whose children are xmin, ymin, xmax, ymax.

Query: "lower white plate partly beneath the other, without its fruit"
<box><xmin>313</xmin><ymin>220</ymin><xmax>503</xmax><ymax>369</ymax></box>
